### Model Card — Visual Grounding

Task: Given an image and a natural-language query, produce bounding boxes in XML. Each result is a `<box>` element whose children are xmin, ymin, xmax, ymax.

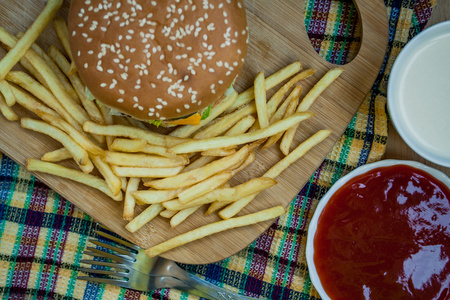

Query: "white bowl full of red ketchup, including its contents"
<box><xmin>306</xmin><ymin>160</ymin><xmax>450</xmax><ymax>300</ymax></box>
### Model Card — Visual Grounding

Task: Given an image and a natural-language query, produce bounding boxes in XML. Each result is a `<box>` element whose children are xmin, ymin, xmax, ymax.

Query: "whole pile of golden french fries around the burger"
<box><xmin>0</xmin><ymin>0</ymin><xmax>343</xmax><ymax>256</ymax></box>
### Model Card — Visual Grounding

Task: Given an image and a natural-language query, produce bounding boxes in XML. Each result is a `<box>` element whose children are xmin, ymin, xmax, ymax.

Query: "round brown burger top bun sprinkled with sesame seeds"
<box><xmin>68</xmin><ymin>0</ymin><xmax>247</xmax><ymax>120</ymax></box>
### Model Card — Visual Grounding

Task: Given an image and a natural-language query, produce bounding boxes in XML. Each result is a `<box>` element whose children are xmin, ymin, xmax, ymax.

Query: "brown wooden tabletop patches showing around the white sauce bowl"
<box><xmin>384</xmin><ymin>0</ymin><xmax>450</xmax><ymax>176</ymax></box>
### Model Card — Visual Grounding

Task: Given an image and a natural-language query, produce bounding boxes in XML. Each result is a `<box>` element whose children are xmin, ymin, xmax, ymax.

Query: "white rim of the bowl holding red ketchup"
<box><xmin>306</xmin><ymin>159</ymin><xmax>450</xmax><ymax>300</ymax></box>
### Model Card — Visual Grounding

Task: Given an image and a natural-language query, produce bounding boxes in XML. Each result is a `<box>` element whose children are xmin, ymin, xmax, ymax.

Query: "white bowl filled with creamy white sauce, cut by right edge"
<box><xmin>387</xmin><ymin>21</ymin><xmax>450</xmax><ymax>167</ymax></box>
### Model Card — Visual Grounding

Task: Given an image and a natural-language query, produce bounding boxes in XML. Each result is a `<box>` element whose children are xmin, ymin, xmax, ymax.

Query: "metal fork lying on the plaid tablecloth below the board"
<box><xmin>78</xmin><ymin>230</ymin><xmax>256</xmax><ymax>300</ymax></box>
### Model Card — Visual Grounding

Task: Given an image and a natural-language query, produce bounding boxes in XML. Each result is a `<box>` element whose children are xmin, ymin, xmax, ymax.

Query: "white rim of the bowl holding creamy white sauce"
<box><xmin>387</xmin><ymin>20</ymin><xmax>450</xmax><ymax>167</ymax></box>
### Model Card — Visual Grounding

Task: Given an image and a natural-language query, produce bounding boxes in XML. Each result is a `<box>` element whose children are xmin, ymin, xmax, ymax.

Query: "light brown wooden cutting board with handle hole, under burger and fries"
<box><xmin>0</xmin><ymin>0</ymin><xmax>388</xmax><ymax>264</ymax></box>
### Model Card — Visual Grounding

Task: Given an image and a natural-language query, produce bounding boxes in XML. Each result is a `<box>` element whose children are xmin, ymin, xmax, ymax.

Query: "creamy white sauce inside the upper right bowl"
<box><xmin>398</xmin><ymin>33</ymin><xmax>450</xmax><ymax>159</ymax></box>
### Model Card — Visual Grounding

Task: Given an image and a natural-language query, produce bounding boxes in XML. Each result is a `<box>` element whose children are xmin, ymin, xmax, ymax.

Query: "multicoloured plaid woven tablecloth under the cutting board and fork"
<box><xmin>0</xmin><ymin>0</ymin><xmax>436</xmax><ymax>299</ymax></box>
